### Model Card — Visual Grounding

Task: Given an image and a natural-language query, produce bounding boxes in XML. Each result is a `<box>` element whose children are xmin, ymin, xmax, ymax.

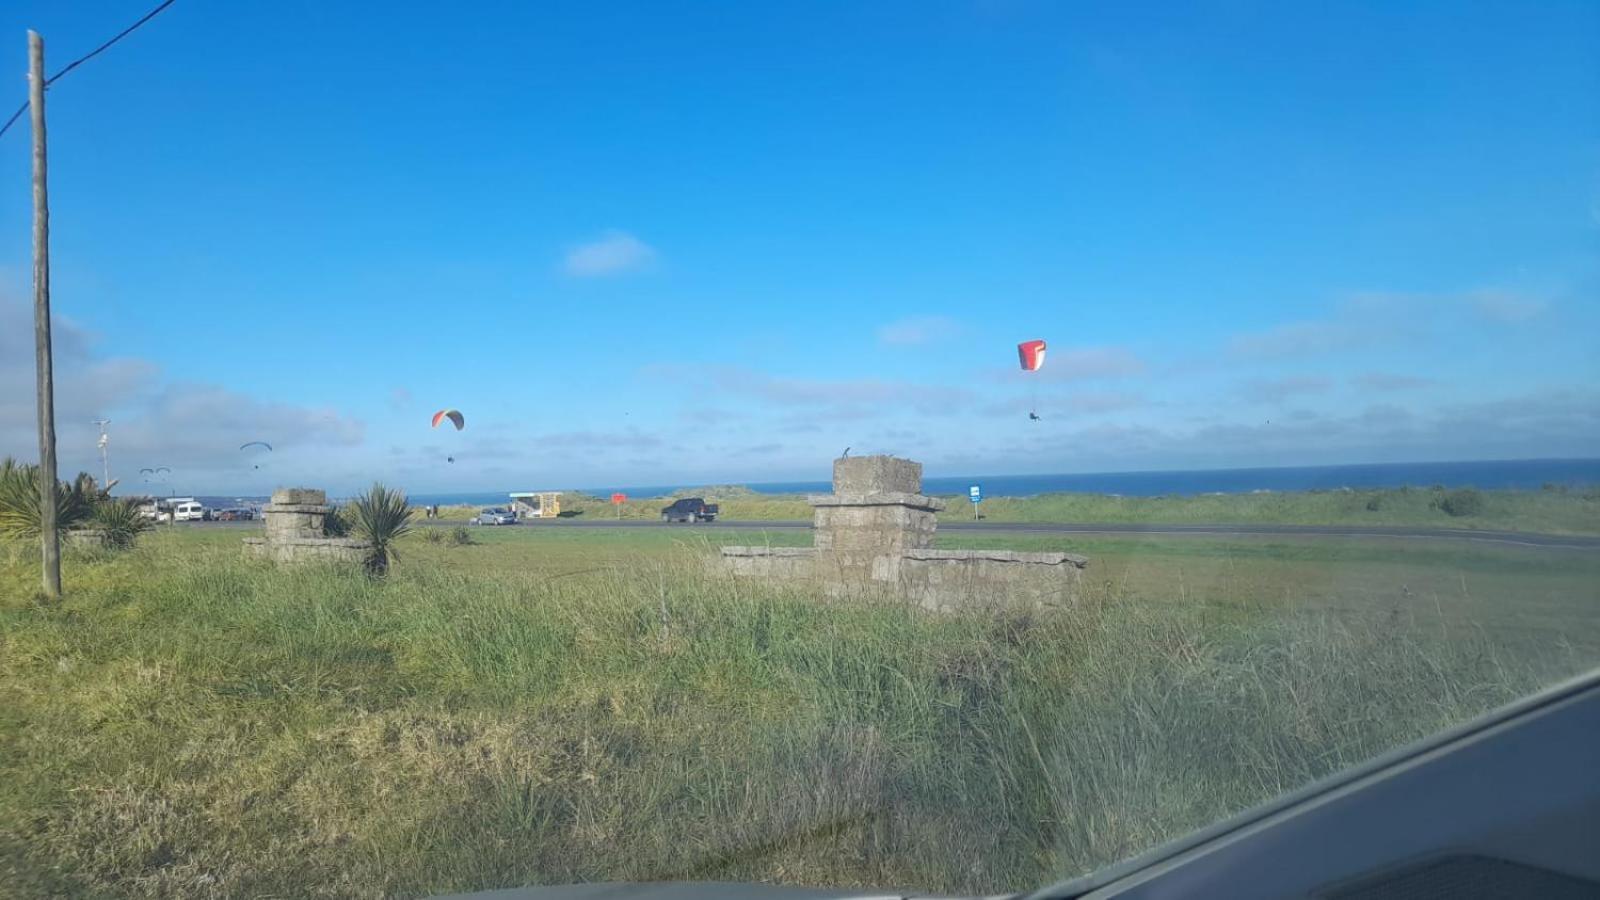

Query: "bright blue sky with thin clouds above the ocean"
<box><xmin>0</xmin><ymin>0</ymin><xmax>1600</xmax><ymax>492</ymax></box>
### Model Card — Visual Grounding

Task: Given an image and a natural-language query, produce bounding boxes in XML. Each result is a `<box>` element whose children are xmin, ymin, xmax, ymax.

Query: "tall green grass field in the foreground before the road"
<box><xmin>0</xmin><ymin>527</ymin><xmax>1600</xmax><ymax>897</ymax></box>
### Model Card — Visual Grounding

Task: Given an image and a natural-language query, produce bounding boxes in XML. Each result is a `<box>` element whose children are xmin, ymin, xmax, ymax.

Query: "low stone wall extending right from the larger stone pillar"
<box><xmin>899</xmin><ymin>549</ymin><xmax>1088</xmax><ymax>610</ymax></box>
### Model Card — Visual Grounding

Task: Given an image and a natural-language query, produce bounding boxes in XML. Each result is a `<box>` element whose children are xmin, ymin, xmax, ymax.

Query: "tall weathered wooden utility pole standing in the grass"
<box><xmin>27</xmin><ymin>30</ymin><xmax>61</xmax><ymax>599</ymax></box>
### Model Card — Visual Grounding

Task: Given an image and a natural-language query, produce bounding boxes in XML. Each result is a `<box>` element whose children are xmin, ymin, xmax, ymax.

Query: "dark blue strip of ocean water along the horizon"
<box><xmin>411</xmin><ymin>460</ymin><xmax>1600</xmax><ymax>506</ymax></box>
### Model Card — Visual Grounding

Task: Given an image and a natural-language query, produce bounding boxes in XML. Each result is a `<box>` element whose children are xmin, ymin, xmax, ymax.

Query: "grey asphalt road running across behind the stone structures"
<box><xmin>200</xmin><ymin>517</ymin><xmax>1600</xmax><ymax>549</ymax></box>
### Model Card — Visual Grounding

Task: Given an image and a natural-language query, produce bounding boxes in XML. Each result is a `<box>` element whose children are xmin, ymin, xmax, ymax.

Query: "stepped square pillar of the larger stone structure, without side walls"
<box><xmin>806</xmin><ymin>456</ymin><xmax>944</xmax><ymax>586</ymax></box>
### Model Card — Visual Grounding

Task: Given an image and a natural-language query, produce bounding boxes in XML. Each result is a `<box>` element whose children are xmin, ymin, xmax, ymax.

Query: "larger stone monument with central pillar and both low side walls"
<box><xmin>722</xmin><ymin>456</ymin><xmax>1088</xmax><ymax>610</ymax></box>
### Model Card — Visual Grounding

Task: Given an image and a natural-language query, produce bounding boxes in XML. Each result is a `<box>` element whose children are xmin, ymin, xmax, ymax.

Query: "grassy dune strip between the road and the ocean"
<box><xmin>428</xmin><ymin>488</ymin><xmax>1600</xmax><ymax>535</ymax></box>
